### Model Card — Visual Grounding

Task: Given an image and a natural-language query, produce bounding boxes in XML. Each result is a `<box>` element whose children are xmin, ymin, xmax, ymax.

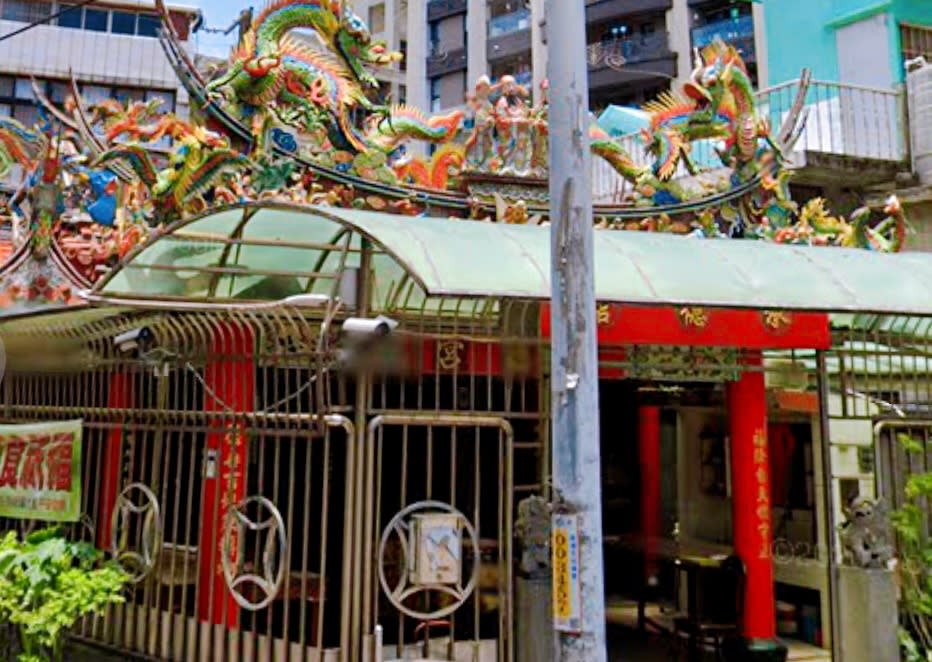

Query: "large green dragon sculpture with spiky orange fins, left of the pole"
<box><xmin>207</xmin><ymin>0</ymin><xmax>463</xmax><ymax>153</ymax></box>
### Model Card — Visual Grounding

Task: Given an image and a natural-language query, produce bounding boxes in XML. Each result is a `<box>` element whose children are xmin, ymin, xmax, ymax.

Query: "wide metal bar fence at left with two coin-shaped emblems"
<box><xmin>0</xmin><ymin>308</ymin><xmax>354</xmax><ymax>660</ymax></box>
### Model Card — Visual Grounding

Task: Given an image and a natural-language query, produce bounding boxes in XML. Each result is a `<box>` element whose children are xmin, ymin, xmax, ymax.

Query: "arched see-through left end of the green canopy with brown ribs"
<box><xmin>95</xmin><ymin>207</ymin><xmax>411</xmax><ymax>302</ymax></box>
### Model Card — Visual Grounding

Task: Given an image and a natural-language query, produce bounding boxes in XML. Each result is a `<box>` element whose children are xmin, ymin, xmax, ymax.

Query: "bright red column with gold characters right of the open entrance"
<box><xmin>728</xmin><ymin>354</ymin><xmax>779</xmax><ymax>660</ymax></box>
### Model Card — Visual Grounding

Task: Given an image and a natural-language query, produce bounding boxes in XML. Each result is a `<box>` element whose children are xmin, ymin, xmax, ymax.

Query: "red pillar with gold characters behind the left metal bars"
<box><xmin>197</xmin><ymin>323</ymin><xmax>255</xmax><ymax>628</ymax></box>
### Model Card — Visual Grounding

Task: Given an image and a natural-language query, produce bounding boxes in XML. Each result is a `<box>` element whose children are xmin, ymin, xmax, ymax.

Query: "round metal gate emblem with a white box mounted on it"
<box><xmin>378</xmin><ymin>501</ymin><xmax>481</xmax><ymax>621</ymax></box>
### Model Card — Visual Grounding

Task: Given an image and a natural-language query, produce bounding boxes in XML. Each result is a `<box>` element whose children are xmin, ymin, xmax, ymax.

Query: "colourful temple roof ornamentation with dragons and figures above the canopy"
<box><xmin>0</xmin><ymin>0</ymin><xmax>907</xmax><ymax>307</ymax></box>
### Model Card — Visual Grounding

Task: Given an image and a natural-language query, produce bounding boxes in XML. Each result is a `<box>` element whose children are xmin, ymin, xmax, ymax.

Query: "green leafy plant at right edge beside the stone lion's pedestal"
<box><xmin>892</xmin><ymin>435</ymin><xmax>932</xmax><ymax>662</ymax></box>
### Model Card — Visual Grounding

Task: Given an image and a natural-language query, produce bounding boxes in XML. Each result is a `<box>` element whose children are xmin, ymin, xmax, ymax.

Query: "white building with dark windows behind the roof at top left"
<box><xmin>0</xmin><ymin>0</ymin><xmax>201</xmax><ymax>126</ymax></box>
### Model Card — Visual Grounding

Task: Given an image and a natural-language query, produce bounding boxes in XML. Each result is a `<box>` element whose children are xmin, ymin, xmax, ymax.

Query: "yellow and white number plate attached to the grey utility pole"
<box><xmin>551</xmin><ymin>515</ymin><xmax>582</xmax><ymax>633</ymax></box>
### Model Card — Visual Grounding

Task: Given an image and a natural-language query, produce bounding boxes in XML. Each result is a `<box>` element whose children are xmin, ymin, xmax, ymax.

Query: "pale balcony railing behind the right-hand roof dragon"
<box><xmin>593</xmin><ymin>80</ymin><xmax>908</xmax><ymax>203</ymax></box>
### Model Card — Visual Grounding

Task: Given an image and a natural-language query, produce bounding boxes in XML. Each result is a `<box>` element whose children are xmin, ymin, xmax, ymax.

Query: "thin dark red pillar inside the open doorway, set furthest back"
<box><xmin>638</xmin><ymin>407</ymin><xmax>661</xmax><ymax>585</ymax></box>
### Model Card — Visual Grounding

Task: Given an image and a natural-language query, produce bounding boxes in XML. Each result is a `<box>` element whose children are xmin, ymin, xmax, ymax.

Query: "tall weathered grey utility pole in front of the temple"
<box><xmin>547</xmin><ymin>0</ymin><xmax>606</xmax><ymax>662</ymax></box>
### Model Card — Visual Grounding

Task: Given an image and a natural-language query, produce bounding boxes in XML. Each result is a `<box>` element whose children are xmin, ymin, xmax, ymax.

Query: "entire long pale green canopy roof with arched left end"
<box><xmin>95</xmin><ymin>205</ymin><xmax>932</xmax><ymax>315</ymax></box>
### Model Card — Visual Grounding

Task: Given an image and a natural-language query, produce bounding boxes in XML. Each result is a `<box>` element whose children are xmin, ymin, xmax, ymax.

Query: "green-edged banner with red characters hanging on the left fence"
<box><xmin>0</xmin><ymin>421</ymin><xmax>82</xmax><ymax>522</ymax></box>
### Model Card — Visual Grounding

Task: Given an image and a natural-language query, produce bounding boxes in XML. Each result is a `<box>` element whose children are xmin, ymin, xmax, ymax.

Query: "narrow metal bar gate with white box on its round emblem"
<box><xmin>362</xmin><ymin>413</ymin><xmax>514</xmax><ymax>660</ymax></box>
